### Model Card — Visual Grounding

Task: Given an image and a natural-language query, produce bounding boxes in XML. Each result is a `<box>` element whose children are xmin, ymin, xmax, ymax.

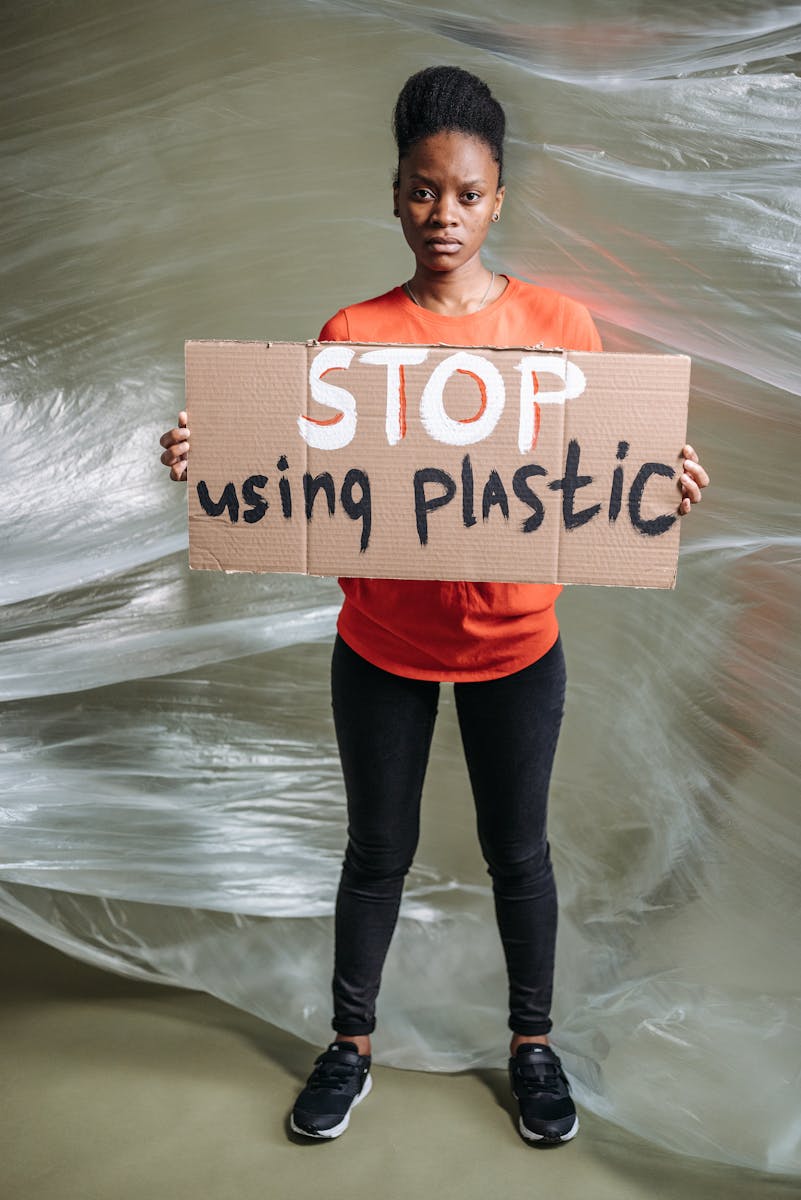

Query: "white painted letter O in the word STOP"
<box><xmin>420</xmin><ymin>350</ymin><xmax>506</xmax><ymax>446</ymax></box>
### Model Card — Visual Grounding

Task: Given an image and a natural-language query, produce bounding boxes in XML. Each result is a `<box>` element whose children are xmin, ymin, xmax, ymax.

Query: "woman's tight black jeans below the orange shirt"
<box><xmin>332</xmin><ymin>637</ymin><xmax>565</xmax><ymax>1037</ymax></box>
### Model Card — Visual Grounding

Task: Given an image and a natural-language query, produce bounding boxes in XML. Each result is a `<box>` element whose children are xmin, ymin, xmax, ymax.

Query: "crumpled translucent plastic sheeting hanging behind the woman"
<box><xmin>0</xmin><ymin>0</ymin><xmax>801</xmax><ymax>1171</ymax></box>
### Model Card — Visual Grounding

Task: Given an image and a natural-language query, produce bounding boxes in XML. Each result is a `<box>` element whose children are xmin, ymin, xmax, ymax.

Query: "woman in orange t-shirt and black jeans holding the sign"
<box><xmin>161</xmin><ymin>67</ymin><xmax>709</xmax><ymax>1145</ymax></box>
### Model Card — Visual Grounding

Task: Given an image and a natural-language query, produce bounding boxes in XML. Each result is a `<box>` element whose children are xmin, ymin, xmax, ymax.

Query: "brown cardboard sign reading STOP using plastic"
<box><xmin>186</xmin><ymin>341</ymin><xmax>689</xmax><ymax>588</ymax></box>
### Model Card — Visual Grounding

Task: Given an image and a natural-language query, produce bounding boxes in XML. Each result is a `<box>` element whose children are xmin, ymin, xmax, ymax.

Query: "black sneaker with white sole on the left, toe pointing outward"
<box><xmin>289</xmin><ymin>1042</ymin><xmax>373</xmax><ymax>1138</ymax></box>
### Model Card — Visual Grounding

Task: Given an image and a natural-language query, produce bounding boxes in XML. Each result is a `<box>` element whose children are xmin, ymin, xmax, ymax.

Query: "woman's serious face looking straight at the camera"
<box><xmin>395</xmin><ymin>131</ymin><xmax>505</xmax><ymax>271</ymax></box>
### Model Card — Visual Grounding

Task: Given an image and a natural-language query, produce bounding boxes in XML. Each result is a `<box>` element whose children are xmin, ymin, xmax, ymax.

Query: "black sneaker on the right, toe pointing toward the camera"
<box><xmin>508</xmin><ymin>1042</ymin><xmax>578</xmax><ymax>1145</ymax></box>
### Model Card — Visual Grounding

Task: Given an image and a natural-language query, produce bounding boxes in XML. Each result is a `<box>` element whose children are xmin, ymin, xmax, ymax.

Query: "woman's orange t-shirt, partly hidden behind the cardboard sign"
<box><xmin>319</xmin><ymin>277</ymin><xmax>602</xmax><ymax>683</ymax></box>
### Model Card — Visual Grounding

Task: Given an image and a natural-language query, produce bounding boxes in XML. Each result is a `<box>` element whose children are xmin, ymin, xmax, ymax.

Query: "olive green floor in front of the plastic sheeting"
<box><xmin>0</xmin><ymin>922</ymin><xmax>801</xmax><ymax>1200</ymax></box>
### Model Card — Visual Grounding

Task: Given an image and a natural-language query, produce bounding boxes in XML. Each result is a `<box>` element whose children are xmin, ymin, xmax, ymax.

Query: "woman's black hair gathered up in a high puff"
<box><xmin>392</xmin><ymin>67</ymin><xmax>506</xmax><ymax>186</ymax></box>
